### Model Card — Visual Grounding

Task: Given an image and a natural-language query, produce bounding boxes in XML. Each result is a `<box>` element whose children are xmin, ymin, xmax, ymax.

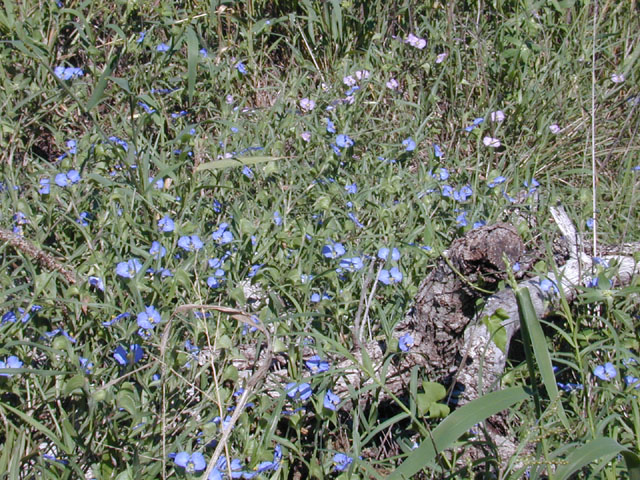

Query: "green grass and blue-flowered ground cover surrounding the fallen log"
<box><xmin>0</xmin><ymin>0</ymin><xmax>640</xmax><ymax>479</ymax></box>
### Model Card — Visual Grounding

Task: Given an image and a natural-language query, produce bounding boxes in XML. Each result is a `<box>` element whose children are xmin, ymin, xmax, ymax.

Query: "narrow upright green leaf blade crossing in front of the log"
<box><xmin>516</xmin><ymin>288</ymin><xmax>570</xmax><ymax>430</ymax></box>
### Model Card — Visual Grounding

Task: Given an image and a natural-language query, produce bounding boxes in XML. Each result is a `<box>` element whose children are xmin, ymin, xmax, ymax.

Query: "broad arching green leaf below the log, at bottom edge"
<box><xmin>387</xmin><ymin>387</ymin><xmax>529</xmax><ymax>479</ymax></box>
